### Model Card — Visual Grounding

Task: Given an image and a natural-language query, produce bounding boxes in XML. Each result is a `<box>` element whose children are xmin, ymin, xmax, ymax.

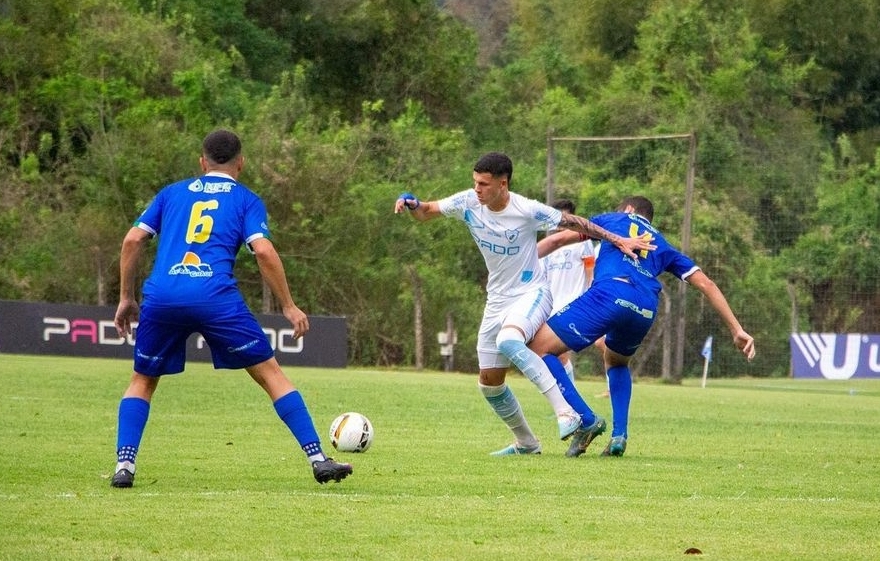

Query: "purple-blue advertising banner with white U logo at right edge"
<box><xmin>790</xmin><ymin>333</ymin><xmax>880</xmax><ymax>380</ymax></box>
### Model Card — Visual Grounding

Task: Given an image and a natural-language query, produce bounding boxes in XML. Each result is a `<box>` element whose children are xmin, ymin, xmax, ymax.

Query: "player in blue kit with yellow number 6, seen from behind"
<box><xmin>111</xmin><ymin>130</ymin><xmax>352</xmax><ymax>487</ymax></box>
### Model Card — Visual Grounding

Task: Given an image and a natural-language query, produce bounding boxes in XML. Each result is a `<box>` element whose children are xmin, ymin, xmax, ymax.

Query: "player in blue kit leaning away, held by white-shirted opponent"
<box><xmin>524</xmin><ymin>196</ymin><xmax>755</xmax><ymax>457</ymax></box>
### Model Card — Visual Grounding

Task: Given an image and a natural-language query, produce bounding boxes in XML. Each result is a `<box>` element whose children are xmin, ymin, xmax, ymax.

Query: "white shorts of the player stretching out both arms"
<box><xmin>477</xmin><ymin>287</ymin><xmax>553</xmax><ymax>369</ymax></box>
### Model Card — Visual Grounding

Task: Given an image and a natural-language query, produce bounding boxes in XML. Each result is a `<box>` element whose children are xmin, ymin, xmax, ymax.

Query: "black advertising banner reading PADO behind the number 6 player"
<box><xmin>0</xmin><ymin>300</ymin><xmax>348</xmax><ymax>368</ymax></box>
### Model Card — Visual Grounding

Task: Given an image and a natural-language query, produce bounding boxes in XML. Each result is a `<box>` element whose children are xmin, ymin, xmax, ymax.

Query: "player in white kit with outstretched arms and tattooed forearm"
<box><xmin>394</xmin><ymin>152</ymin><xmax>653</xmax><ymax>456</ymax></box>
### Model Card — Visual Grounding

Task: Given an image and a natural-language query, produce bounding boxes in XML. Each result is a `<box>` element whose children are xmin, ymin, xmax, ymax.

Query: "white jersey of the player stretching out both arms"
<box><xmin>438</xmin><ymin>189</ymin><xmax>562</xmax><ymax>302</ymax></box>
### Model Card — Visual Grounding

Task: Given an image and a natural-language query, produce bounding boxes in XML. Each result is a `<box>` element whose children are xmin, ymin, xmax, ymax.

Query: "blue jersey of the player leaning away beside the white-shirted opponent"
<box><xmin>590</xmin><ymin>212</ymin><xmax>699</xmax><ymax>298</ymax></box>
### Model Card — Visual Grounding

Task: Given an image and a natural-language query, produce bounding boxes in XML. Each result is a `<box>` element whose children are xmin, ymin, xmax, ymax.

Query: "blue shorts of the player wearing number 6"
<box><xmin>134</xmin><ymin>302</ymin><xmax>275</xmax><ymax>376</ymax></box>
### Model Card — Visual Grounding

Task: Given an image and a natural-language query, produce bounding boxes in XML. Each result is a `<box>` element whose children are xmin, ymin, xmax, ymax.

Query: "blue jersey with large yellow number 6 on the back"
<box><xmin>134</xmin><ymin>173</ymin><xmax>269</xmax><ymax>306</ymax></box>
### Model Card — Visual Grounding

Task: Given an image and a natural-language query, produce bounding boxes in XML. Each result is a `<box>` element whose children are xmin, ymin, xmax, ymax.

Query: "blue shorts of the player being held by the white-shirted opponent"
<box><xmin>547</xmin><ymin>280</ymin><xmax>657</xmax><ymax>356</ymax></box>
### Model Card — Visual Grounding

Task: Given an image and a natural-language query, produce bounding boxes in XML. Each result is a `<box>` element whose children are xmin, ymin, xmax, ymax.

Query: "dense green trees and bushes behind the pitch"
<box><xmin>0</xmin><ymin>0</ymin><xmax>880</xmax><ymax>375</ymax></box>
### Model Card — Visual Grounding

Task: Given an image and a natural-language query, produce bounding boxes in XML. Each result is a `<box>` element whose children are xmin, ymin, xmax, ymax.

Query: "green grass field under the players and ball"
<box><xmin>0</xmin><ymin>355</ymin><xmax>880</xmax><ymax>561</ymax></box>
